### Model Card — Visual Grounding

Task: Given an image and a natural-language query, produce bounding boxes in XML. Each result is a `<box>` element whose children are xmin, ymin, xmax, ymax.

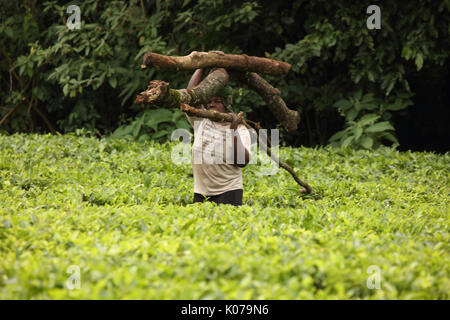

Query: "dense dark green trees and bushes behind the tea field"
<box><xmin>0</xmin><ymin>0</ymin><xmax>450</xmax><ymax>152</ymax></box>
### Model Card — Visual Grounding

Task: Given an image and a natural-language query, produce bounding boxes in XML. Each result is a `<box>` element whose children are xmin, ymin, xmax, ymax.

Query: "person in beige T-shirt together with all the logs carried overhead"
<box><xmin>134</xmin><ymin>51</ymin><xmax>312</xmax><ymax>195</ymax></box>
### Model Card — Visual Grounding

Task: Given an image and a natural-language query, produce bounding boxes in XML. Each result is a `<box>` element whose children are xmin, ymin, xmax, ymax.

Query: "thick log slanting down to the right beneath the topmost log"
<box><xmin>232</xmin><ymin>72</ymin><xmax>300</xmax><ymax>132</ymax></box>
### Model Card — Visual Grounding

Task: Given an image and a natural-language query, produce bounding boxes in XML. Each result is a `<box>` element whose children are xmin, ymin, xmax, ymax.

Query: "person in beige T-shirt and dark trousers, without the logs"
<box><xmin>186</xmin><ymin>69</ymin><xmax>251</xmax><ymax>206</ymax></box>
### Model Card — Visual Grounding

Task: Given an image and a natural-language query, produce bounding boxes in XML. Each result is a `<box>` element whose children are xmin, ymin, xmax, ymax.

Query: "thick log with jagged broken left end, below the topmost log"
<box><xmin>134</xmin><ymin>68</ymin><xmax>230</xmax><ymax>108</ymax></box>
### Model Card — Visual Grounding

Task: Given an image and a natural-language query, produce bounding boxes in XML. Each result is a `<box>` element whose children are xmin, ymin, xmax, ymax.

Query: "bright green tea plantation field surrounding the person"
<box><xmin>0</xmin><ymin>134</ymin><xmax>450</xmax><ymax>299</ymax></box>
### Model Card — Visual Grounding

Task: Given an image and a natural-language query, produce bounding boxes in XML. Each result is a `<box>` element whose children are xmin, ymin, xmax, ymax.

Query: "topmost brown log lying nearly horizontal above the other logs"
<box><xmin>141</xmin><ymin>51</ymin><xmax>291</xmax><ymax>75</ymax></box>
